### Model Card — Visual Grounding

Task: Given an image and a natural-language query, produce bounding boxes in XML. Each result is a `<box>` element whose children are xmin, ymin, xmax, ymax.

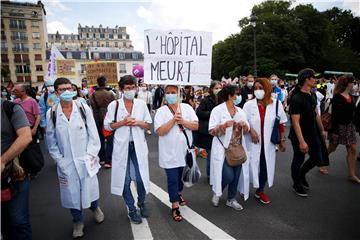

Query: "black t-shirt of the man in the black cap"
<box><xmin>289</xmin><ymin>92</ymin><xmax>320</xmax><ymax>145</ymax></box>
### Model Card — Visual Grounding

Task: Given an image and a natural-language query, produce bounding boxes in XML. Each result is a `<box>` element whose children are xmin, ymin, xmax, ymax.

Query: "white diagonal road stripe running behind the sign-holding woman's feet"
<box><xmin>150</xmin><ymin>182</ymin><xmax>235</xmax><ymax>239</ymax></box>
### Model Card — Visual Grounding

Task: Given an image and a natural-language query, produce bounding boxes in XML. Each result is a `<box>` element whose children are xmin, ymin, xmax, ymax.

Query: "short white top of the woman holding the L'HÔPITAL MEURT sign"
<box><xmin>154</xmin><ymin>103</ymin><xmax>198</xmax><ymax>169</ymax></box>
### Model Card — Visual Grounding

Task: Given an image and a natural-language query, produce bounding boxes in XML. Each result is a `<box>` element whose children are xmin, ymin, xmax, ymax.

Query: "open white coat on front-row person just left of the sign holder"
<box><xmin>104</xmin><ymin>98</ymin><xmax>152</xmax><ymax>196</ymax></box>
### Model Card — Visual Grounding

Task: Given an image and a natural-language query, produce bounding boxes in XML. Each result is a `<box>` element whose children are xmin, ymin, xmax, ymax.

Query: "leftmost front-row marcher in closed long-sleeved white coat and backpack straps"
<box><xmin>46</xmin><ymin>78</ymin><xmax>104</xmax><ymax>238</ymax></box>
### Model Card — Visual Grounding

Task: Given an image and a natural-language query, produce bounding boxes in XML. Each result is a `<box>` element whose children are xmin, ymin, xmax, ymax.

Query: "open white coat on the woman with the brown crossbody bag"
<box><xmin>209</xmin><ymin>103</ymin><xmax>249</xmax><ymax>200</ymax></box>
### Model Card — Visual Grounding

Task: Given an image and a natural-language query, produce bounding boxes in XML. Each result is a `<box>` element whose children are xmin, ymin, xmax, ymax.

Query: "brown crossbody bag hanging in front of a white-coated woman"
<box><xmin>216</xmin><ymin>127</ymin><xmax>247</xmax><ymax>167</ymax></box>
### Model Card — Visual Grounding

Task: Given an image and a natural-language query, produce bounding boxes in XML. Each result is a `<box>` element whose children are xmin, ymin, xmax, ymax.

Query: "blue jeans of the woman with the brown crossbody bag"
<box><xmin>221</xmin><ymin>160</ymin><xmax>242</xmax><ymax>200</ymax></box>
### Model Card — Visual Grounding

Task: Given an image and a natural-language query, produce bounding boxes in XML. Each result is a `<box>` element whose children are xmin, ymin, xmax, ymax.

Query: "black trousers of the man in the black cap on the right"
<box><xmin>291</xmin><ymin>140</ymin><xmax>323</xmax><ymax>186</ymax></box>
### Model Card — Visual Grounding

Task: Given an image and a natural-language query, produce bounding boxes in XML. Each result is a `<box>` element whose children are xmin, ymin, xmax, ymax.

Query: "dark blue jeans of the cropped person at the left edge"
<box><xmin>1</xmin><ymin>177</ymin><xmax>32</xmax><ymax>240</ymax></box>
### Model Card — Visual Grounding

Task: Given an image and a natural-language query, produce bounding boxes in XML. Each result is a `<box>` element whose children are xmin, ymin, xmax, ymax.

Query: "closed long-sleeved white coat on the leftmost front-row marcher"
<box><xmin>46</xmin><ymin>101</ymin><xmax>100</xmax><ymax>210</ymax></box>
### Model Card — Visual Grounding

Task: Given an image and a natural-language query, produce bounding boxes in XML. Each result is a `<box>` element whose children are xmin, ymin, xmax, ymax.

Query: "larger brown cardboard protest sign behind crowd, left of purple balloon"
<box><xmin>85</xmin><ymin>61</ymin><xmax>119</xmax><ymax>85</ymax></box>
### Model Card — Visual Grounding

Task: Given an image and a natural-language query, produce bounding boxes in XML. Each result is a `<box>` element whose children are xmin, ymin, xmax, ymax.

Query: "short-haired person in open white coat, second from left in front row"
<box><xmin>104</xmin><ymin>75</ymin><xmax>152</xmax><ymax>224</ymax></box>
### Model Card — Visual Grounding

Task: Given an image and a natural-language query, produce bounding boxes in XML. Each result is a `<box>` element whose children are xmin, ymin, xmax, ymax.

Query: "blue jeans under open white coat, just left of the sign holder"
<box><xmin>123</xmin><ymin>142</ymin><xmax>146</xmax><ymax>211</ymax></box>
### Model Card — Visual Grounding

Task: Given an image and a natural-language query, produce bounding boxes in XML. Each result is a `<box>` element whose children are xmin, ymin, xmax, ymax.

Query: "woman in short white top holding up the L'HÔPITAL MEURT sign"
<box><xmin>154</xmin><ymin>85</ymin><xmax>199</xmax><ymax>221</ymax></box>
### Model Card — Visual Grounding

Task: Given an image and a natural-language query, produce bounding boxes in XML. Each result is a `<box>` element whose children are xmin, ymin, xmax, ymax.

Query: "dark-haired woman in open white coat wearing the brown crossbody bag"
<box><xmin>209</xmin><ymin>85</ymin><xmax>249</xmax><ymax>210</ymax></box>
